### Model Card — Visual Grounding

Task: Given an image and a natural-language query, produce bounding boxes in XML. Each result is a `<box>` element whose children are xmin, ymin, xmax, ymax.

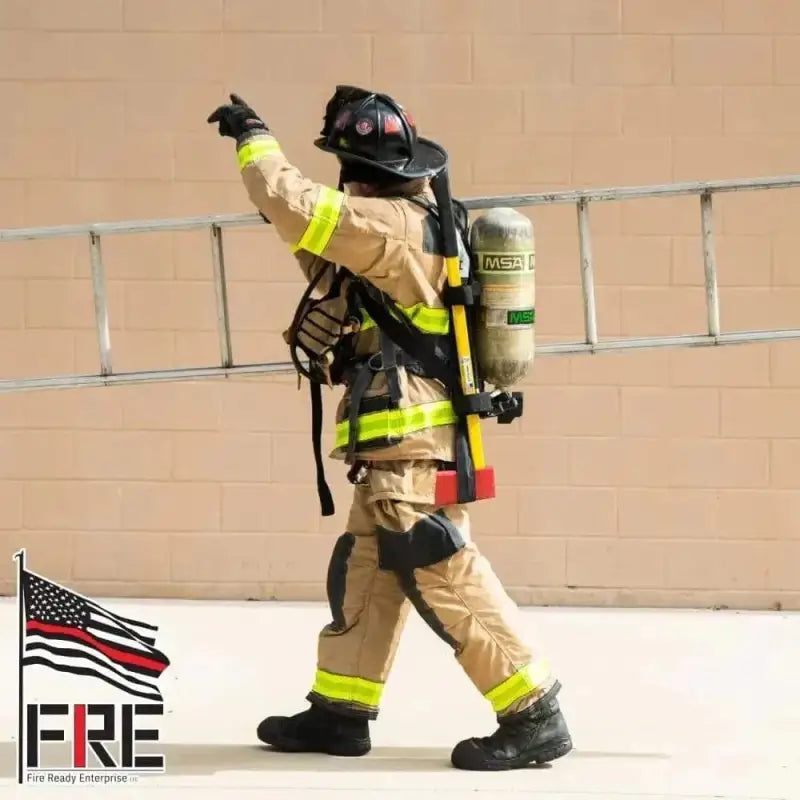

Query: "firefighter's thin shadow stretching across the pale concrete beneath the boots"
<box><xmin>0</xmin><ymin>742</ymin><xmax>669</xmax><ymax>778</ymax></box>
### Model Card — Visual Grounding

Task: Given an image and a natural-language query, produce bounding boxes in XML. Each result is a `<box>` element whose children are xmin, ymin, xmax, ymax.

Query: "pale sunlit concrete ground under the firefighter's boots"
<box><xmin>0</xmin><ymin>598</ymin><xmax>800</xmax><ymax>800</ymax></box>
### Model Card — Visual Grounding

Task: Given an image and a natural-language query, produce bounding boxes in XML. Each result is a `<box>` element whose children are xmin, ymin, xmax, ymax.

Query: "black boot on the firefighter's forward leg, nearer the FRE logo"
<box><xmin>257</xmin><ymin>705</ymin><xmax>372</xmax><ymax>756</ymax></box>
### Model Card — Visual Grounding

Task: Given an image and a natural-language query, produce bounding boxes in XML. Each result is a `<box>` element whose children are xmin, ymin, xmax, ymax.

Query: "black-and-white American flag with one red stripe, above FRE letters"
<box><xmin>20</xmin><ymin>567</ymin><xmax>169</xmax><ymax>702</ymax></box>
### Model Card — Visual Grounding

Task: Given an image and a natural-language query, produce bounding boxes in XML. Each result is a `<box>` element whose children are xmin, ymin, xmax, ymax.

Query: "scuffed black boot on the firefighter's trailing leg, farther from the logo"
<box><xmin>450</xmin><ymin>682</ymin><xmax>572</xmax><ymax>771</ymax></box>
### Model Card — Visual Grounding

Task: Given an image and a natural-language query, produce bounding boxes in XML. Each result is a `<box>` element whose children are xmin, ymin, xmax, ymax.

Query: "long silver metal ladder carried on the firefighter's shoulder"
<box><xmin>0</xmin><ymin>175</ymin><xmax>800</xmax><ymax>393</ymax></box>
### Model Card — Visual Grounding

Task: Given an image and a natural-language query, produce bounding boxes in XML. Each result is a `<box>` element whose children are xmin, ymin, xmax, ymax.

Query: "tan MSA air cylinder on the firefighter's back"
<box><xmin>470</xmin><ymin>208</ymin><xmax>536</xmax><ymax>390</ymax></box>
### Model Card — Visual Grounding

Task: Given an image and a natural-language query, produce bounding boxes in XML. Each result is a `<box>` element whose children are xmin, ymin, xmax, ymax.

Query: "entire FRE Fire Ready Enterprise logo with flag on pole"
<box><xmin>14</xmin><ymin>548</ymin><xmax>170</xmax><ymax>784</ymax></box>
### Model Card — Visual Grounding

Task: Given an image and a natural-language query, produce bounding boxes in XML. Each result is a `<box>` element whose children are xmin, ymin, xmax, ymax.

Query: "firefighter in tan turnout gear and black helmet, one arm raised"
<box><xmin>208</xmin><ymin>86</ymin><xmax>572</xmax><ymax>770</ymax></box>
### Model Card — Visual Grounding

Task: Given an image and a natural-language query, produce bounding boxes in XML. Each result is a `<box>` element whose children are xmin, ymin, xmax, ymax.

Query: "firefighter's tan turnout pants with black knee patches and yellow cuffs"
<box><xmin>308</xmin><ymin>461</ymin><xmax>555</xmax><ymax>719</ymax></box>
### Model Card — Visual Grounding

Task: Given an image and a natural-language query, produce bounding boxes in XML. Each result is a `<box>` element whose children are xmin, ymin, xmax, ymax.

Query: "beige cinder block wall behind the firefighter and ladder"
<box><xmin>0</xmin><ymin>0</ymin><xmax>800</xmax><ymax>608</ymax></box>
